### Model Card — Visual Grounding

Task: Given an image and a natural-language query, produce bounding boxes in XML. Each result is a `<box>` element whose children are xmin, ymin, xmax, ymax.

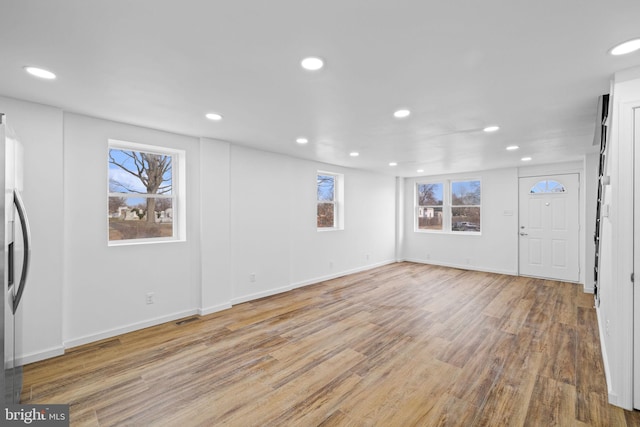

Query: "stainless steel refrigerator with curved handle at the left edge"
<box><xmin>0</xmin><ymin>113</ymin><xmax>31</xmax><ymax>405</ymax></box>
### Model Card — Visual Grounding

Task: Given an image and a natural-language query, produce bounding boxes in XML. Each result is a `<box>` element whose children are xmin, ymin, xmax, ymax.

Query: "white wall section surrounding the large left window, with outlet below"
<box><xmin>63</xmin><ymin>113</ymin><xmax>200</xmax><ymax>347</ymax></box>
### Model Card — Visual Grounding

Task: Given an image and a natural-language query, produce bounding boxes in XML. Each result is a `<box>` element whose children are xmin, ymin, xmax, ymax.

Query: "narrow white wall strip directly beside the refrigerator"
<box><xmin>0</xmin><ymin>97</ymin><xmax>64</xmax><ymax>362</ymax></box>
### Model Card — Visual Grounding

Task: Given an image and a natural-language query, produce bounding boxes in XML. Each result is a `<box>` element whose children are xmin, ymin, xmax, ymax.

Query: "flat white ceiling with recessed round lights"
<box><xmin>0</xmin><ymin>0</ymin><xmax>640</xmax><ymax>176</ymax></box>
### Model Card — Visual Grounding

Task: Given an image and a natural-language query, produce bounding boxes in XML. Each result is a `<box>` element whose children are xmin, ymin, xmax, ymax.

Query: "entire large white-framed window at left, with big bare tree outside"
<box><xmin>107</xmin><ymin>140</ymin><xmax>184</xmax><ymax>244</ymax></box>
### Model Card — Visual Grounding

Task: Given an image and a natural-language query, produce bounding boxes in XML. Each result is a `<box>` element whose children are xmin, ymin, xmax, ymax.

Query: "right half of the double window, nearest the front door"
<box><xmin>451</xmin><ymin>180</ymin><xmax>481</xmax><ymax>232</ymax></box>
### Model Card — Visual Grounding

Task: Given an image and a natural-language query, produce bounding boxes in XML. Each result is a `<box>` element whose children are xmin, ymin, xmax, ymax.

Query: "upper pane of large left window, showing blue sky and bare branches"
<box><xmin>109</xmin><ymin>148</ymin><xmax>172</xmax><ymax>195</ymax></box>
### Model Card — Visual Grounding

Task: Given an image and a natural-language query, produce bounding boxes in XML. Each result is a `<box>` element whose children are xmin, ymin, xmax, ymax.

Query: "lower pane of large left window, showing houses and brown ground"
<box><xmin>109</xmin><ymin>197</ymin><xmax>173</xmax><ymax>240</ymax></box>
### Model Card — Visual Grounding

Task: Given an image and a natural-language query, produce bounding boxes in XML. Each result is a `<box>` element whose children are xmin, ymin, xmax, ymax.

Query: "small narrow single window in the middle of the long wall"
<box><xmin>316</xmin><ymin>171</ymin><xmax>343</xmax><ymax>230</ymax></box>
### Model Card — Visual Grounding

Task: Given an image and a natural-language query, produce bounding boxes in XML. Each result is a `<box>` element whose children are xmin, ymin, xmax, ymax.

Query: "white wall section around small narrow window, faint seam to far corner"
<box><xmin>289</xmin><ymin>155</ymin><xmax>396</xmax><ymax>286</ymax></box>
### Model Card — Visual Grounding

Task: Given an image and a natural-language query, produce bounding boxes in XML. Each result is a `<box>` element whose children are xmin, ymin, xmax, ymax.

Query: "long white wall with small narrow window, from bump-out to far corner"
<box><xmin>231</xmin><ymin>146</ymin><xmax>395</xmax><ymax>303</ymax></box>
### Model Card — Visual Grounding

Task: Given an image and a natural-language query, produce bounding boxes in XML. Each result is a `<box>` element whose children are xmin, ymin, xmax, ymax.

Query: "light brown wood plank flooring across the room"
<box><xmin>23</xmin><ymin>263</ymin><xmax>640</xmax><ymax>427</ymax></box>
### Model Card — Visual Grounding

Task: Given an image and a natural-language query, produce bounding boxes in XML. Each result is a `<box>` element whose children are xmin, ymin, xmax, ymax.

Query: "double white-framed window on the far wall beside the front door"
<box><xmin>416</xmin><ymin>180</ymin><xmax>481</xmax><ymax>233</ymax></box>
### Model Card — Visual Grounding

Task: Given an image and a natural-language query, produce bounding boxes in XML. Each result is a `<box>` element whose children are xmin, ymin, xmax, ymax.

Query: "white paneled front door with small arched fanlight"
<box><xmin>518</xmin><ymin>174</ymin><xmax>580</xmax><ymax>282</ymax></box>
